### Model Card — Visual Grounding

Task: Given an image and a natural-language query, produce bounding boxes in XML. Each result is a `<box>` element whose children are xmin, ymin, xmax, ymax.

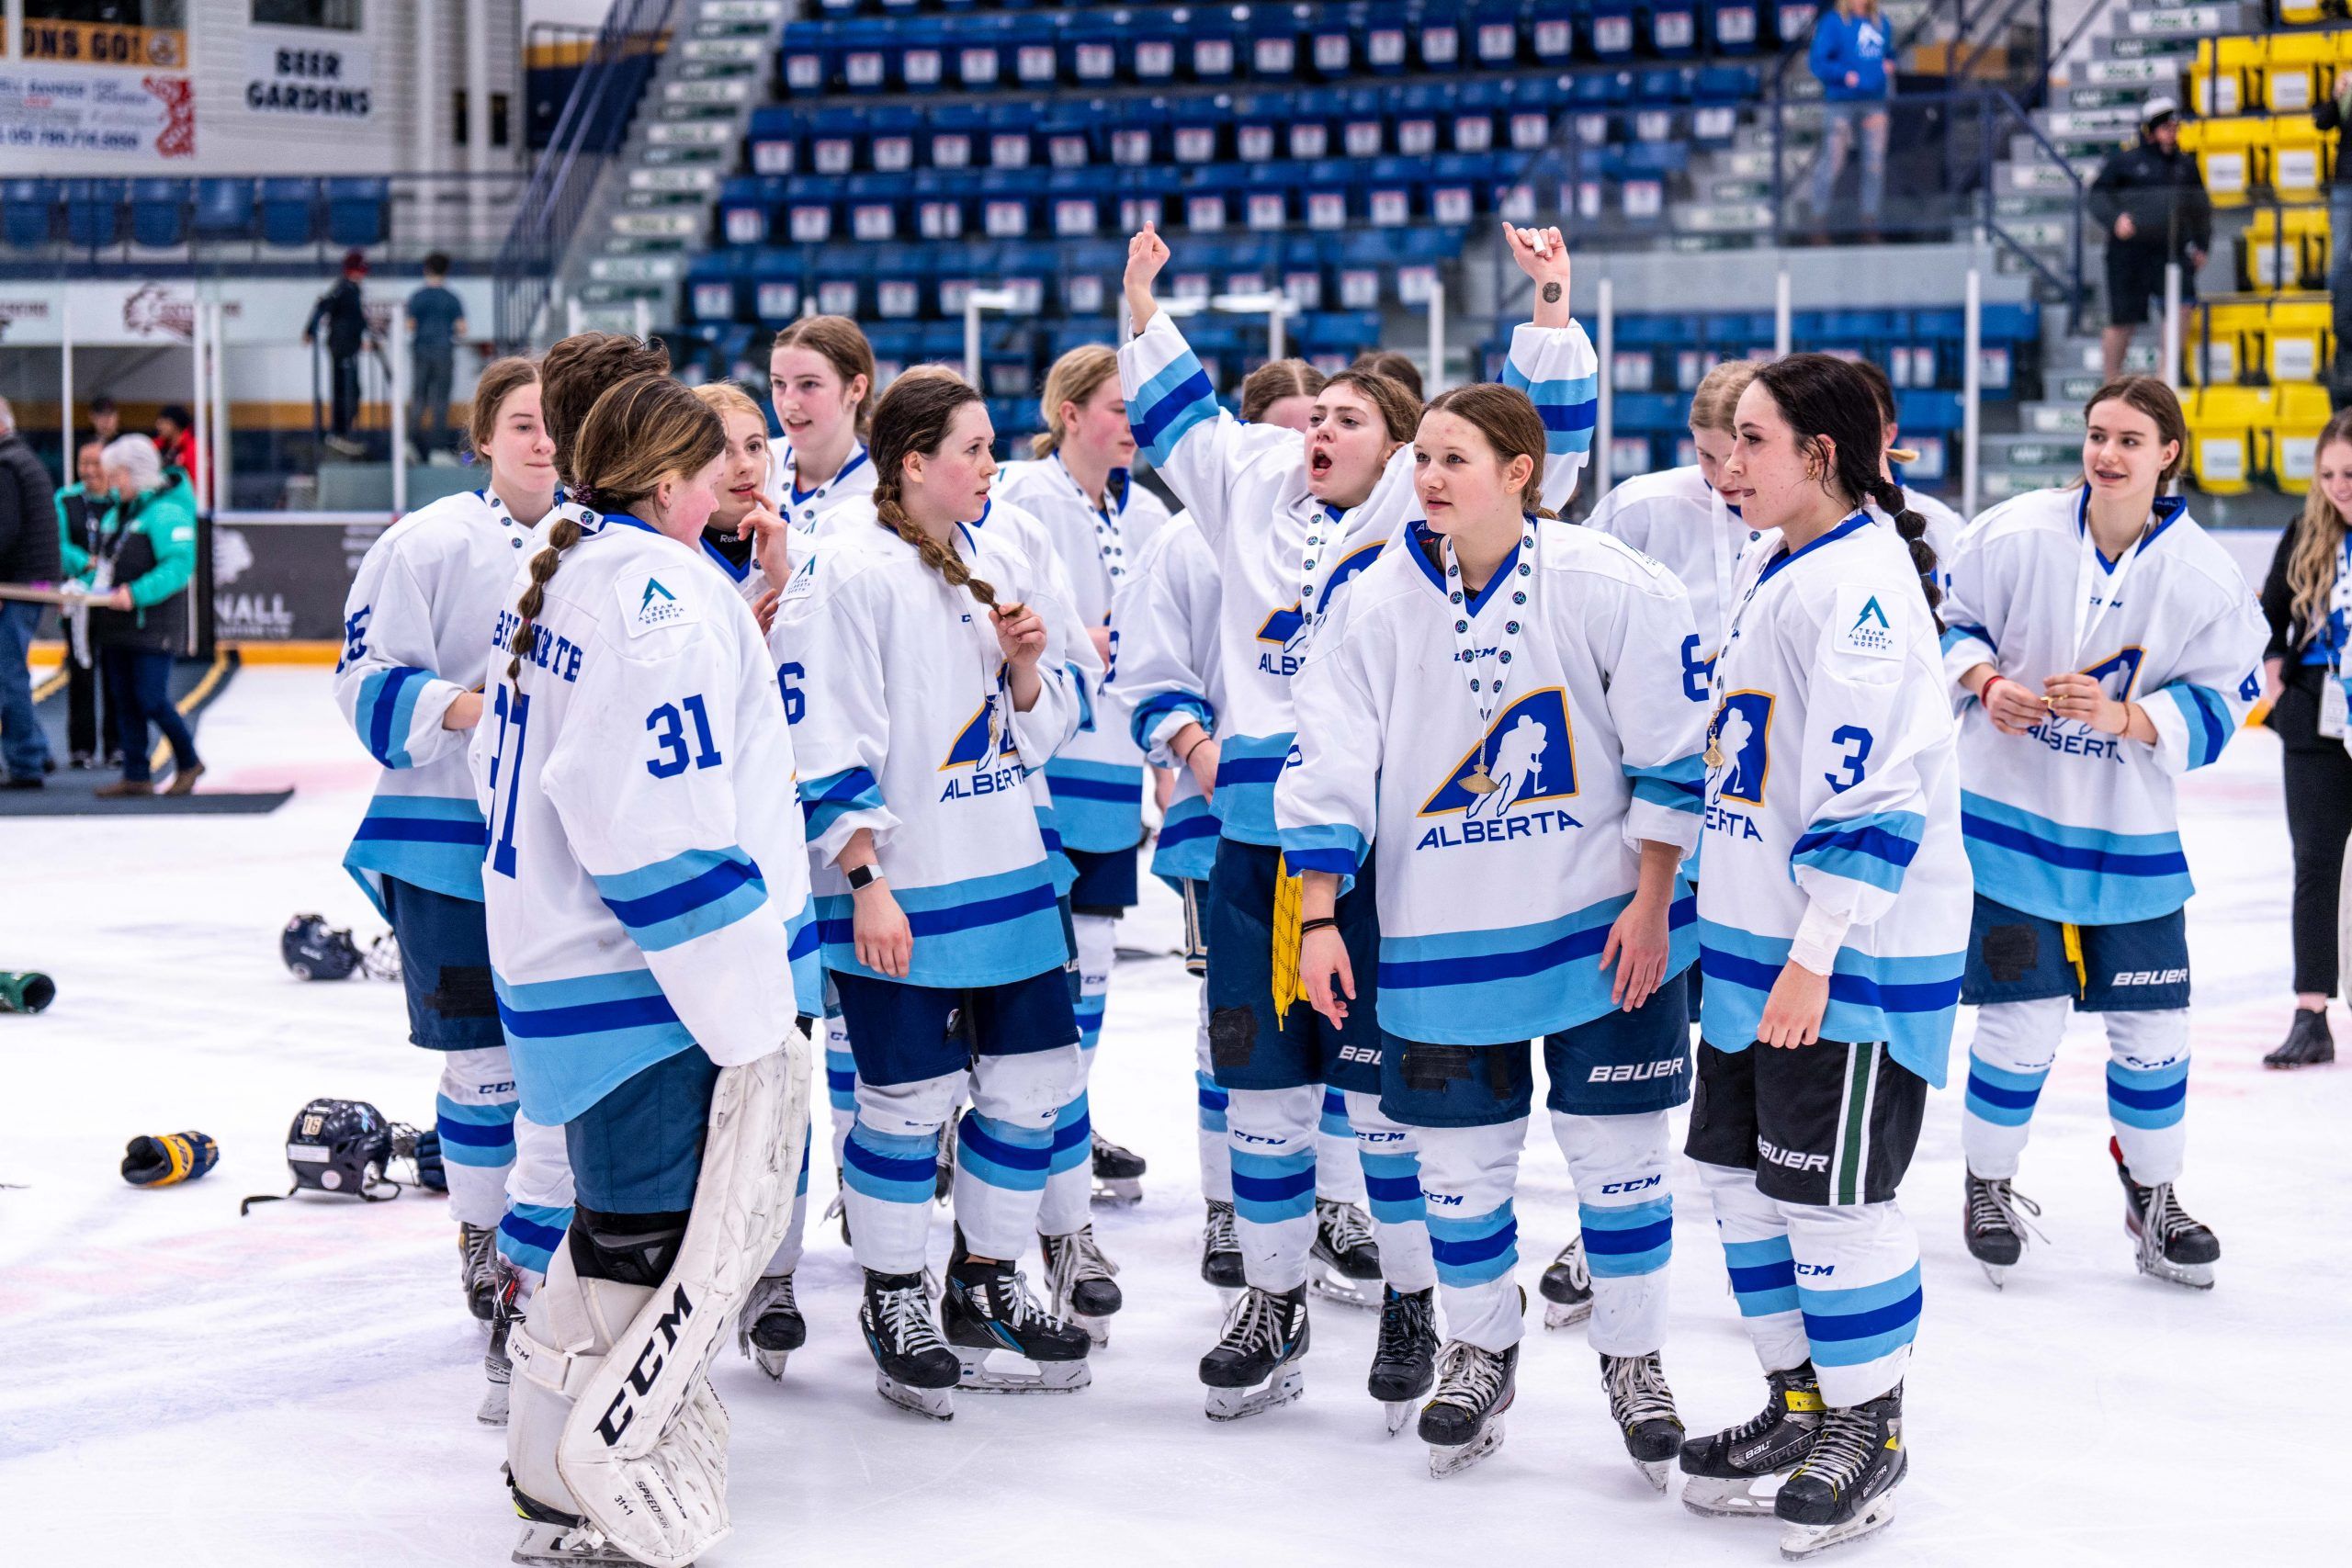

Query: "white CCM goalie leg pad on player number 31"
<box><xmin>555</xmin><ymin>1032</ymin><xmax>809</xmax><ymax>1568</ymax></box>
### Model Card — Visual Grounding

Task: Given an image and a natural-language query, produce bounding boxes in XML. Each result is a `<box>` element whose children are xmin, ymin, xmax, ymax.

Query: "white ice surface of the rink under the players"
<box><xmin>0</xmin><ymin>670</ymin><xmax>2352</xmax><ymax>1568</ymax></box>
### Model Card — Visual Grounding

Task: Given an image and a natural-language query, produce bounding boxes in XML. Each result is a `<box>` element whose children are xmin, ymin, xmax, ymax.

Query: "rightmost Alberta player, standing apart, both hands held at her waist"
<box><xmin>1945</xmin><ymin>376</ymin><xmax>2269</xmax><ymax>1288</ymax></box>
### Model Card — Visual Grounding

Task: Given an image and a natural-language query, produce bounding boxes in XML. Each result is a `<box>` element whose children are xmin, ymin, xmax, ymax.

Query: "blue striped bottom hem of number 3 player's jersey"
<box><xmin>1698</xmin><ymin>919</ymin><xmax>1969</xmax><ymax>1089</ymax></box>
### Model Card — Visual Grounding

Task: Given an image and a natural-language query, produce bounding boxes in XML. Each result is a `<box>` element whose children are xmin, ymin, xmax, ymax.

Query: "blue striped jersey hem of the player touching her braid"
<box><xmin>816</xmin><ymin>858</ymin><xmax>1070</xmax><ymax>987</ymax></box>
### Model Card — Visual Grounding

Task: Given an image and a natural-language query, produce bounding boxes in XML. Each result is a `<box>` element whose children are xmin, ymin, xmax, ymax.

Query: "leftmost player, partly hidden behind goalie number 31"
<box><xmin>334</xmin><ymin>360</ymin><xmax>576</xmax><ymax>1422</ymax></box>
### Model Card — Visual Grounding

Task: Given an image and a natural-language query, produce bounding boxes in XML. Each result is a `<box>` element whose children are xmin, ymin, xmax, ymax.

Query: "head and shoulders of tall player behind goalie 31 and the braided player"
<box><xmin>767</xmin><ymin>315</ymin><xmax>875</xmax><ymax>531</ymax></box>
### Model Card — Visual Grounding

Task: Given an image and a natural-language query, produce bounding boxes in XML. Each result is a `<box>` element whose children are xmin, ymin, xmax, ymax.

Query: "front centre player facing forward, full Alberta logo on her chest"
<box><xmin>1275</xmin><ymin>383</ymin><xmax>1705</xmax><ymax>1491</ymax></box>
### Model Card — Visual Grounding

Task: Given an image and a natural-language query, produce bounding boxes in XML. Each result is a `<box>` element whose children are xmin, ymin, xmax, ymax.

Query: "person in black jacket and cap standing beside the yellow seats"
<box><xmin>2091</xmin><ymin>98</ymin><xmax>2213</xmax><ymax>381</ymax></box>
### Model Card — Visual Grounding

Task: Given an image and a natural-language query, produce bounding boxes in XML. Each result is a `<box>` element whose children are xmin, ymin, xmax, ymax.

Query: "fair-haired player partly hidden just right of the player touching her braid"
<box><xmin>997</xmin><ymin>344</ymin><xmax>1169</xmax><ymax>1222</ymax></box>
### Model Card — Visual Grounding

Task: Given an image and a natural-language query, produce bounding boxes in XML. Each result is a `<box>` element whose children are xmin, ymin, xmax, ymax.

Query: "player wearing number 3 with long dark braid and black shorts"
<box><xmin>1681</xmin><ymin>355</ymin><xmax>1969</xmax><ymax>1556</ymax></box>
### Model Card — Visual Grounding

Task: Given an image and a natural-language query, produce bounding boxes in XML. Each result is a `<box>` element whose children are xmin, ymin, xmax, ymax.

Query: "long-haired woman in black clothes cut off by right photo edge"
<box><xmin>2263</xmin><ymin>412</ymin><xmax>2352</xmax><ymax>1067</ymax></box>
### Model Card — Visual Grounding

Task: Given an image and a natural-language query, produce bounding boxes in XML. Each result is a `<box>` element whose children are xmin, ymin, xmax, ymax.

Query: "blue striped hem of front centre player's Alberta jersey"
<box><xmin>1376</xmin><ymin>888</ymin><xmax>1693</xmax><ymax>1046</ymax></box>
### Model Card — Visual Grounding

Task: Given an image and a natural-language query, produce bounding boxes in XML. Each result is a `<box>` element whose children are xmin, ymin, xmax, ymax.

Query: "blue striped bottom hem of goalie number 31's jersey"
<box><xmin>492</xmin><ymin>968</ymin><xmax>694</xmax><ymax>1126</ymax></box>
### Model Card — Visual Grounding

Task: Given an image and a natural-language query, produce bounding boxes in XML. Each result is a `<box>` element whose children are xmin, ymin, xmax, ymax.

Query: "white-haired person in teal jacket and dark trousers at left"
<box><xmin>80</xmin><ymin>434</ymin><xmax>205</xmax><ymax>799</ymax></box>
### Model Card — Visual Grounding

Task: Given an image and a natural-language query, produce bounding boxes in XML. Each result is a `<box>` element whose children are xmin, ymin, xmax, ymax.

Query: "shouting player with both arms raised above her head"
<box><xmin>1120</xmin><ymin>215</ymin><xmax>1595</xmax><ymax>1420</ymax></box>
